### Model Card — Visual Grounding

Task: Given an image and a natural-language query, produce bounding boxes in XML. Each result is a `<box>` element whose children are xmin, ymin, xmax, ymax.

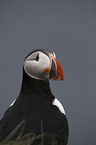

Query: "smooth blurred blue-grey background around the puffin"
<box><xmin>0</xmin><ymin>0</ymin><xmax>96</xmax><ymax>145</ymax></box>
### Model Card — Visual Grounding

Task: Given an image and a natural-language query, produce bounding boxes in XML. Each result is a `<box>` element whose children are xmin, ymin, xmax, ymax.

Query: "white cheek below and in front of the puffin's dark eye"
<box><xmin>24</xmin><ymin>52</ymin><xmax>50</xmax><ymax>79</ymax></box>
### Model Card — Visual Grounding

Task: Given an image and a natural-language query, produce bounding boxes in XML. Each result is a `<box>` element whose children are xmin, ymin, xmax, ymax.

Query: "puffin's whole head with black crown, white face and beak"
<box><xmin>24</xmin><ymin>49</ymin><xmax>64</xmax><ymax>80</ymax></box>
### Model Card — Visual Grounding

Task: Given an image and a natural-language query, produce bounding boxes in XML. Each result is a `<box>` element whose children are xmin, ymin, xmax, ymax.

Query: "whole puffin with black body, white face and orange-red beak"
<box><xmin>0</xmin><ymin>49</ymin><xmax>69</xmax><ymax>145</ymax></box>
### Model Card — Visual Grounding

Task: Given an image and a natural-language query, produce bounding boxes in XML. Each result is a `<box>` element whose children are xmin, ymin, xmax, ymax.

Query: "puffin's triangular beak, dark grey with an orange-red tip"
<box><xmin>49</xmin><ymin>57</ymin><xmax>64</xmax><ymax>80</ymax></box>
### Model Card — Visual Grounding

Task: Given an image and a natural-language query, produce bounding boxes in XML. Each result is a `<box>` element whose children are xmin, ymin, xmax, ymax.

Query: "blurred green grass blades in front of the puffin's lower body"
<box><xmin>0</xmin><ymin>120</ymin><xmax>58</xmax><ymax>145</ymax></box>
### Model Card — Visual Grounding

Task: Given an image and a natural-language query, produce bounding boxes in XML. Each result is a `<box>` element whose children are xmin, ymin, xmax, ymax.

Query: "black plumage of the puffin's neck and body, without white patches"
<box><xmin>0</xmin><ymin>49</ymin><xmax>68</xmax><ymax>145</ymax></box>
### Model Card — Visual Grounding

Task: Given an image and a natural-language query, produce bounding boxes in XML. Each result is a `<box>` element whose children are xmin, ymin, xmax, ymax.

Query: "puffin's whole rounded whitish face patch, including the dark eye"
<box><xmin>24</xmin><ymin>51</ymin><xmax>51</xmax><ymax>79</ymax></box>
